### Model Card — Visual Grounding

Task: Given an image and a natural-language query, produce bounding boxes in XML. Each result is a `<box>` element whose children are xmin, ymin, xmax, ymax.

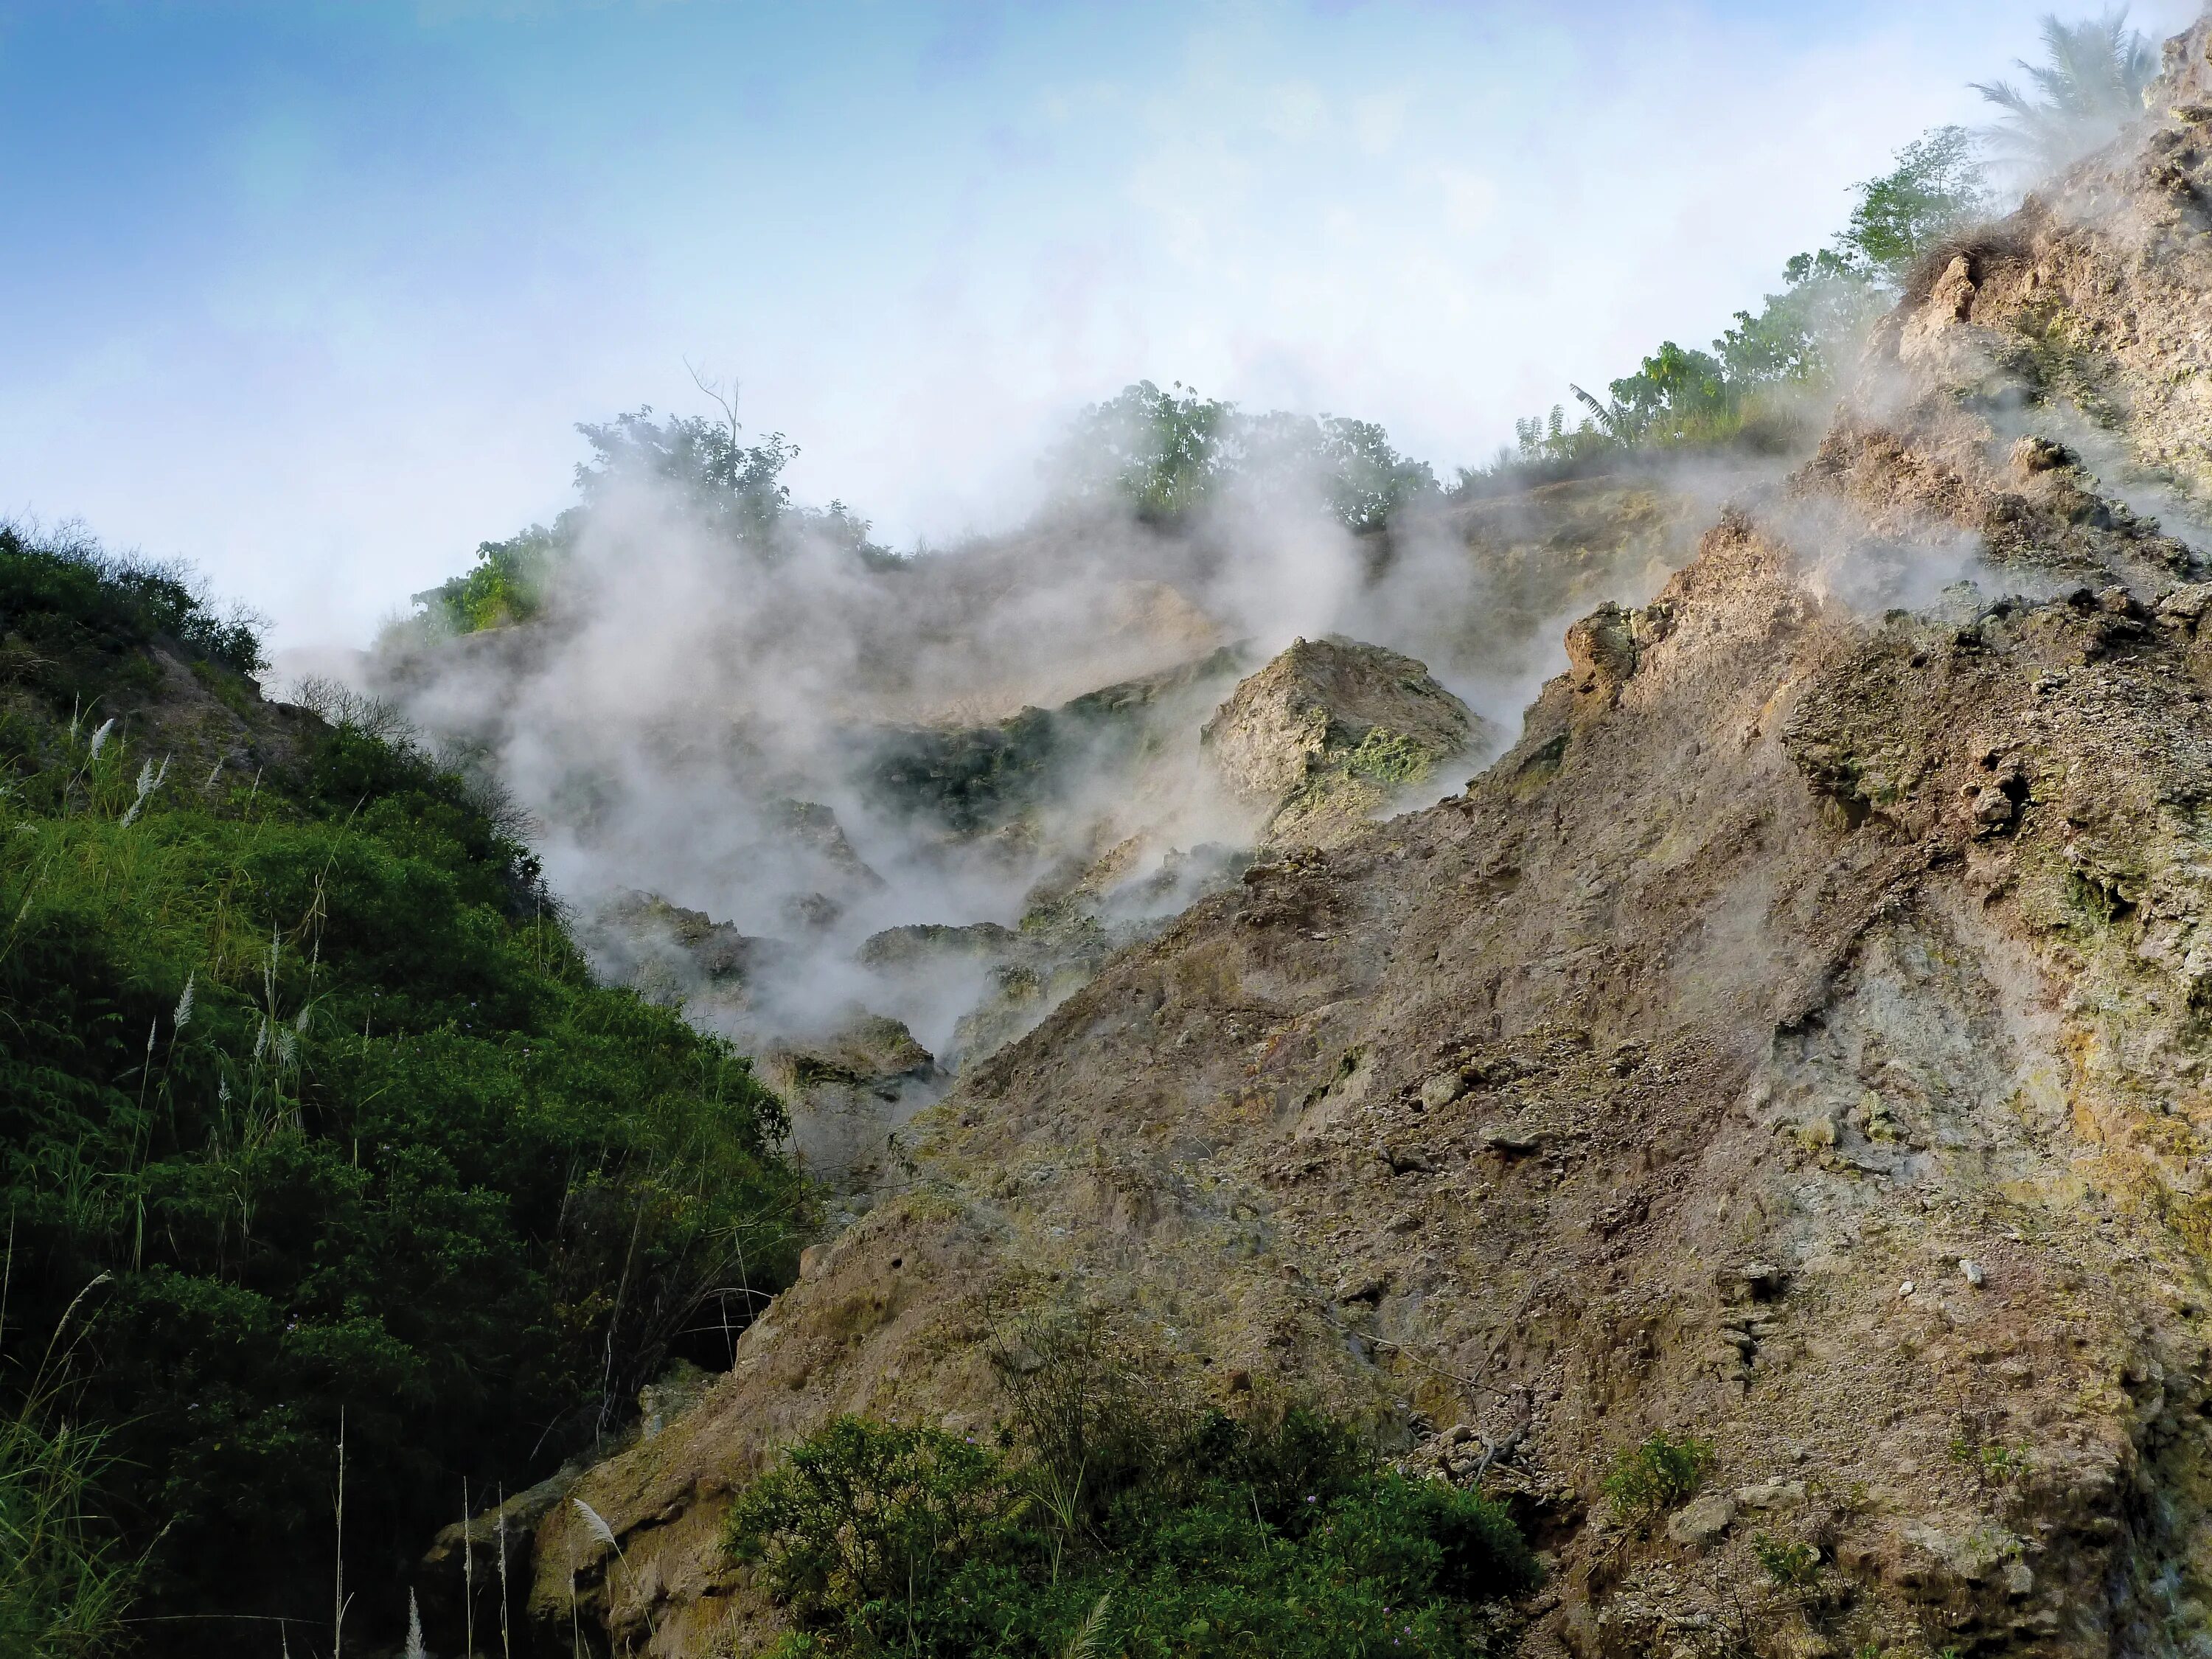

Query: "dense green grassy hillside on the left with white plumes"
<box><xmin>0</xmin><ymin>533</ymin><xmax>803</xmax><ymax>1652</ymax></box>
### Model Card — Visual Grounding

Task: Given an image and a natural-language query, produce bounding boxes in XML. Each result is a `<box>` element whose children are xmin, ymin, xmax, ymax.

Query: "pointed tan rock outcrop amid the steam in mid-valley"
<box><xmin>1203</xmin><ymin>635</ymin><xmax>1489</xmax><ymax>847</ymax></box>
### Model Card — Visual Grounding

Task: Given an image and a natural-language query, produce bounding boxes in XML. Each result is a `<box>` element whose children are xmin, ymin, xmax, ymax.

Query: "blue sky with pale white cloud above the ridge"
<box><xmin>0</xmin><ymin>0</ymin><xmax>2194</xmax><ymax>648</ymax></box>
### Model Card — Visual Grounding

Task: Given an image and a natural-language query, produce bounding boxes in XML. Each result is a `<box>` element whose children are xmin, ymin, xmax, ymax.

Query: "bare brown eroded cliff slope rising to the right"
<box><xmin>538</xmin><ymin>27</ymin><xmax>2212</xmax><ymax>1655</ymax></box>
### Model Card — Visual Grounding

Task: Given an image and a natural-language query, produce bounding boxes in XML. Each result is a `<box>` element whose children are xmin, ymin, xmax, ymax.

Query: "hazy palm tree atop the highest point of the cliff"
<box><xmin>1973</xmin><ymin>7</ymin><xmax>2159</xmax><ymax>179</ymax></box>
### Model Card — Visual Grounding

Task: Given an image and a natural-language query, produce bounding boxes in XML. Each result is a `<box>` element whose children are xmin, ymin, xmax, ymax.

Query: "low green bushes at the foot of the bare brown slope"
<box><xmin>726</xmin><ymin>1327</ymin><xmax>1535</xmax><ymax>1659</ymax></box>
